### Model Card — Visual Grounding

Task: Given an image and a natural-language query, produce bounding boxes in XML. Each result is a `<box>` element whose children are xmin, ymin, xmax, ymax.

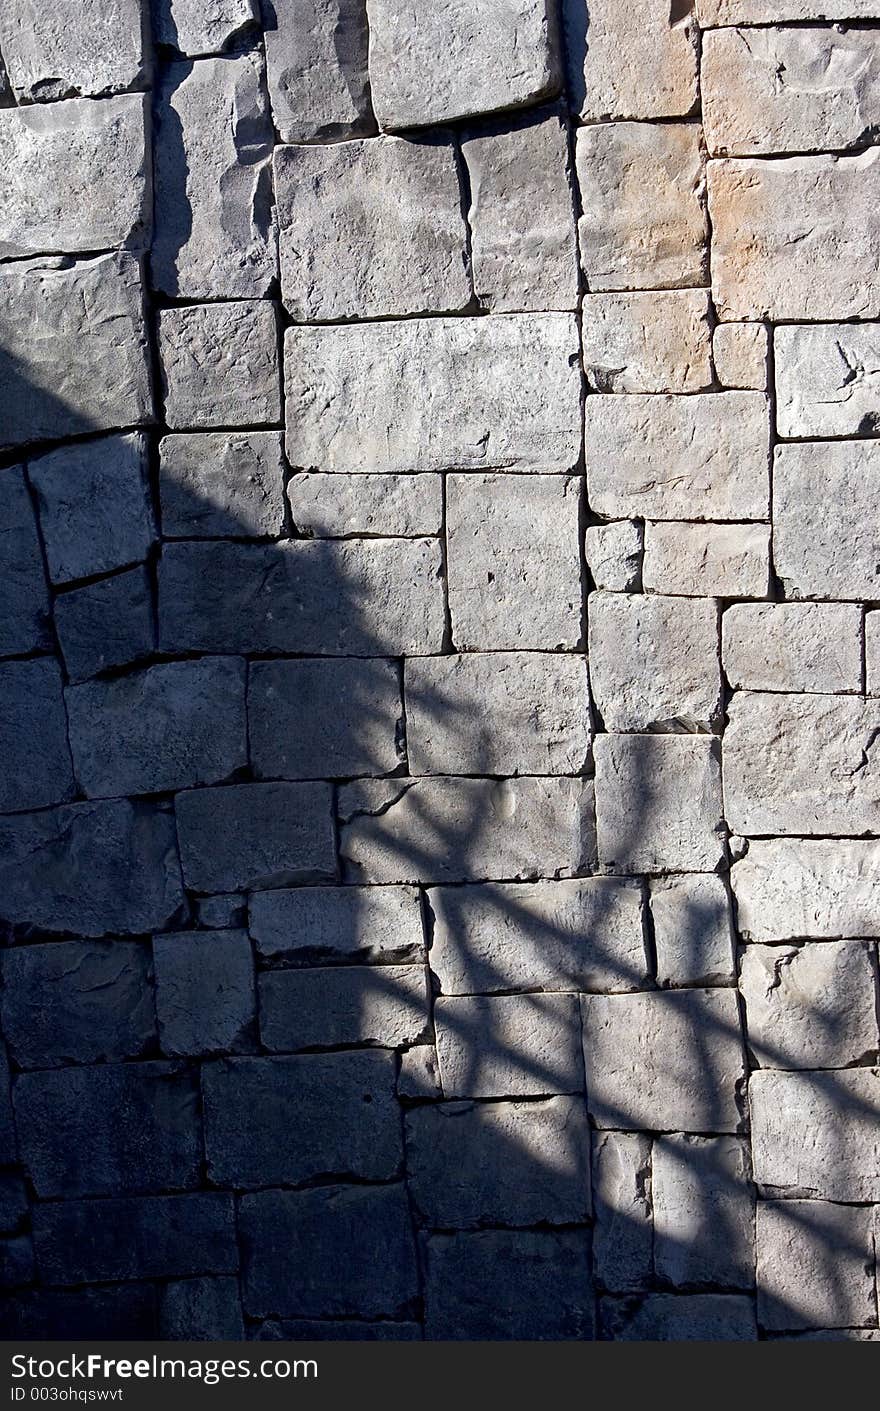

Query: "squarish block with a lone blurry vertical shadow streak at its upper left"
<box><xmin>594</xmin><ymin>735</ymin><xmax>725</xmax><ymax>872</ymax></box>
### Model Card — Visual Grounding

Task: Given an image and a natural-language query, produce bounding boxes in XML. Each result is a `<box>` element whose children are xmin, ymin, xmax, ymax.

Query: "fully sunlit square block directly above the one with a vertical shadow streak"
<box><xmin>587</xmin><ymin>593</ymin><xmax>721</xmax><ymax>732</ymax></box>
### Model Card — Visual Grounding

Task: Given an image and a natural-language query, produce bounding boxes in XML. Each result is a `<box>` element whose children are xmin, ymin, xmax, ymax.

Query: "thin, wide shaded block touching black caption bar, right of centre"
<box><xmin>599</xmin><ymin>1294</ymin><xmax>757</xmax><ymax>1342</ymax></box>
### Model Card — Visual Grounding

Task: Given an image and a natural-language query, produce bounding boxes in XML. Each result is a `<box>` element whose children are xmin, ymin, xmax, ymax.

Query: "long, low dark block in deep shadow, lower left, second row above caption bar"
<box><xmin>34</xmin><ymin>1191</ymin><xmax>238</xmax><ymax>1284</ymax></box>
